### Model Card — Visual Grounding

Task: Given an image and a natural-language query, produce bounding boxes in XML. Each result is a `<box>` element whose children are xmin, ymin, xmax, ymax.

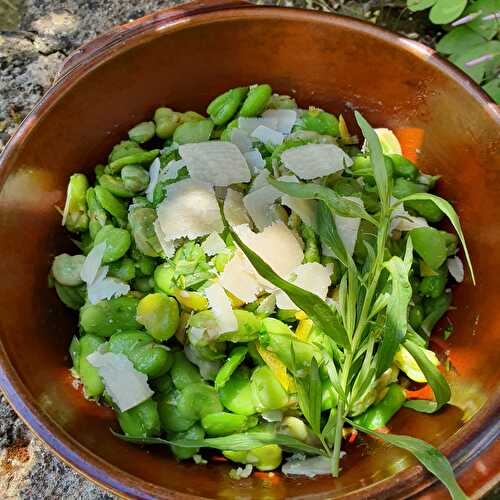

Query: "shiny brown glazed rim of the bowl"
<box><xmin>0</xmin><ymin>0</ymin><xmax>500</xmax><ymax>499</ymax></box>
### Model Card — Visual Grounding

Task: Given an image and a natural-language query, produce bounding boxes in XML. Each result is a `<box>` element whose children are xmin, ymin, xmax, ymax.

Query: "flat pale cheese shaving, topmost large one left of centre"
<box><xmin>179</xmin><ymin>141</ymin><xmax>251</xmax><ymax>186</ymax></box>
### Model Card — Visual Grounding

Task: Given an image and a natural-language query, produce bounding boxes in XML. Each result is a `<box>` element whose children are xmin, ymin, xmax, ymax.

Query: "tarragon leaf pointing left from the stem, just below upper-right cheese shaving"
<box><xmin>268</xmin><ymin>178</ymin><xmax>377</xmax><ymax>225</ymax></box>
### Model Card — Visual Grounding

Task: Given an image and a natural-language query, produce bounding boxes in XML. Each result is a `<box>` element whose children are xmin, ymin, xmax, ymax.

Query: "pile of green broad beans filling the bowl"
<box><xmin>49</xmin><ymin>84</ymin><xmax>457</xmax><ymax>471</ymax></box>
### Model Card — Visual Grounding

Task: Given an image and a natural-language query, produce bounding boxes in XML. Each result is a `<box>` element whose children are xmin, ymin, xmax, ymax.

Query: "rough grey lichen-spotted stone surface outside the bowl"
<box><xmin>0</xmin><ymin>0</ymin><xmax>492</xmax><ymax>500</ymax></box>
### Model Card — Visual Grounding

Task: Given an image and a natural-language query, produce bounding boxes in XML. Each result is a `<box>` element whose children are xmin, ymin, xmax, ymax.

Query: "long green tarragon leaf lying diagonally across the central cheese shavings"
<box><xmin>229</xmin><ymin>227</ymin><xmax>349</xmax><ymax>348</ymax></box>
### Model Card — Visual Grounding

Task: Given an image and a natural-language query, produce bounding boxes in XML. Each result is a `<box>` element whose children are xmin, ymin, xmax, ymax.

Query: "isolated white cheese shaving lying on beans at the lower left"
<box><xmin>87</xmin><ymin>351</ymin><xmax>154</xmax><ymax>411</ymax></box>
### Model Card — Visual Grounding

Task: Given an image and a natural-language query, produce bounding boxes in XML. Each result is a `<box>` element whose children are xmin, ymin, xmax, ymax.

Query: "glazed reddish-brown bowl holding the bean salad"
<box><xmin>0</xmin><ymin>0</ymin><xmax>500</xmax><ymax>498</ymax></box>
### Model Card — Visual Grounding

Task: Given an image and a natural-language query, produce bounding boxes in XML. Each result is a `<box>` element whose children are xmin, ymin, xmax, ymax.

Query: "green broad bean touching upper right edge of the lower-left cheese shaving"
<box><xmin>108</xmin><ymin>332</ymin><xmax>173</xmax><ymax>378</ymax></box>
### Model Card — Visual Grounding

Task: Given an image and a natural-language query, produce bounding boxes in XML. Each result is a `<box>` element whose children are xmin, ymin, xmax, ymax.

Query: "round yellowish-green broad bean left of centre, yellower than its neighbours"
<box><xmin>137</xmin><ymin>293</ymin><xmax>179</xmax><ymax>341</ymax></box>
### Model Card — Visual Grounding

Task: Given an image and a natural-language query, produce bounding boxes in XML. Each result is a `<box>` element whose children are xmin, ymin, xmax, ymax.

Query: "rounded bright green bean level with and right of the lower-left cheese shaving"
<box><xmin>177</xmin><ymin>382</ymin><xmax>223</xmax><ymax>420</ymax></box>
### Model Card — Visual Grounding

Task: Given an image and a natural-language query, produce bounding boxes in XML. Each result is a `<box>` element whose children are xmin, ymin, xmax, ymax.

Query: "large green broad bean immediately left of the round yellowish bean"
<box><xmin>80</xmin><ymin>295</ymin><xmax>141</xmax><ymax>337</ymax></box>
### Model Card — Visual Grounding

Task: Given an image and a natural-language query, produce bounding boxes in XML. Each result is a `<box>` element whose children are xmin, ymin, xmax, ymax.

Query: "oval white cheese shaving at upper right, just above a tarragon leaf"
<box><xmin>281</xmin><ymin>144</ymin><xmax>352</xmax><ymax>179</ymax></box>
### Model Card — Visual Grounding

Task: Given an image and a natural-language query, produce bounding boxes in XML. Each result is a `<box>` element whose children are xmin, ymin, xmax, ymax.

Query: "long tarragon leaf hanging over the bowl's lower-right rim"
<box><xmin>347</xmin><ymin>420</ymin><xmax>467</xmax><ymax>500</ymax></box>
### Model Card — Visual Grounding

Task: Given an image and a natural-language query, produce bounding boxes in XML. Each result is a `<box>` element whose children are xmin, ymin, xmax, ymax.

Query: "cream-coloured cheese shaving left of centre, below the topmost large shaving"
<box><xmin>156</xmin><ymin>180</ymin><xmax>223</xmax><ymax>241</ymax></box>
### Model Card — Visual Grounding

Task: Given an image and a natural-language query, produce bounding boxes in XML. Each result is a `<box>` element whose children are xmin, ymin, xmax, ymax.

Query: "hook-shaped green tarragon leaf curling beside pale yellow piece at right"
<box><xmin>403</xmin><ymin>340</ymin><xmax>451</xmax><ymax>413</ymax></box>
